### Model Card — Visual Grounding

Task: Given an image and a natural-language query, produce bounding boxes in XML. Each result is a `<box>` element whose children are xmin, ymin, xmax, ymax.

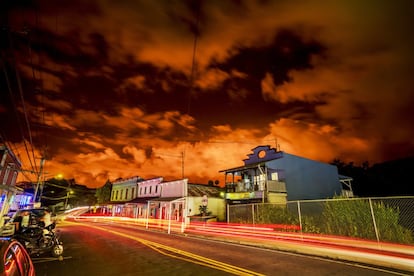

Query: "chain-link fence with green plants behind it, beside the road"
<box><xmin>227</xmin><ymin>197</ymin><xmax>414</xmax><ymax>244</ymax></box>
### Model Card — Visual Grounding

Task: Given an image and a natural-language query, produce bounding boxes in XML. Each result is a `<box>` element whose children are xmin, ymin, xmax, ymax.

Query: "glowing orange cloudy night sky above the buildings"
<box><xmin>0</xmin><ymin>0</ymin><xmax>414</xmax><ymax>187</ymax></box>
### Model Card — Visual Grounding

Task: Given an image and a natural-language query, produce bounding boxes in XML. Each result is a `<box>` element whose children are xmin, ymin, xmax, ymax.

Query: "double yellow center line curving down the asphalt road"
<box><xmin>65</xmin><ymin>222</ymin><xmax>264</xmax><ymax>276</ymax></box>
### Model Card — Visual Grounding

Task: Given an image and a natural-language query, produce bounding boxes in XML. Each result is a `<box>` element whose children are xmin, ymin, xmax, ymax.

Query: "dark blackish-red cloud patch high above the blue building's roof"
<box><xmin>185</xmin><ymin>29</ymin><xmax>324</xmax><ymax>130</ymax></box>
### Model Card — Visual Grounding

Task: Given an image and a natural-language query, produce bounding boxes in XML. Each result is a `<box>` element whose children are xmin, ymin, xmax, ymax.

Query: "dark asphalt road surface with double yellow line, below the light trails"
<box><xmin>33</xmin><ymin>222</ymin><xmax>408</xmax><ymax>276</ymax></box>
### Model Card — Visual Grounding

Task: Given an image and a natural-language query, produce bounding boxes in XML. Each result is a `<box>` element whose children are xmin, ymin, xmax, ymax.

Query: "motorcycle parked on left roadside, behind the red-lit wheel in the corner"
<box><xmin>14</xmin><ymin>222</ymin><xmax>63</xmax><ymax>257</ymax></box>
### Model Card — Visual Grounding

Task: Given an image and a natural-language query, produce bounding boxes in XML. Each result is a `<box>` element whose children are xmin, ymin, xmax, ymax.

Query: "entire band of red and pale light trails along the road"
<box><xmin>61</xmin><ymin>210</ymin><xmax>414</xmax><ymax>272</ymax></box>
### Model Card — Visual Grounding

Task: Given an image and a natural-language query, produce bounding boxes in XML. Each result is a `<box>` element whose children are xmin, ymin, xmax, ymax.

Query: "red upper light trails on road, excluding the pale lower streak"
<box><xmin>62</xmin><ymin>213</ymin><xmax>414</xmax><ymax>260</ymax></box>
